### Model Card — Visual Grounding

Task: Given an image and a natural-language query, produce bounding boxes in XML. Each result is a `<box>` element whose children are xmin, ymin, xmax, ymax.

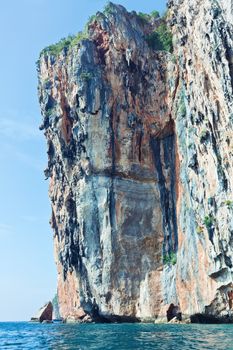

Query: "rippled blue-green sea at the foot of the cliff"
<box><xmin>0</xmin><ymin>322</ymin><xmax>233</xmax><ymax>350</ymax></box>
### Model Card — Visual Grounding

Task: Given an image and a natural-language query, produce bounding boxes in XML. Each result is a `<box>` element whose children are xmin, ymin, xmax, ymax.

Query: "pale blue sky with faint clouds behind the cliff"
<box><xmin>0</xmin><ymin>0</ymin><xmax>165</xmax><ymax>321</ymax></box>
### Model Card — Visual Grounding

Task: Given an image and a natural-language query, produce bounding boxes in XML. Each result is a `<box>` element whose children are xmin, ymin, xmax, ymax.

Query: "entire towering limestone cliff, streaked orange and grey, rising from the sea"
<box><xmin>38</xmin><ymin>0</ymin><xmax>233</xmax><ymax>321</ymax></box>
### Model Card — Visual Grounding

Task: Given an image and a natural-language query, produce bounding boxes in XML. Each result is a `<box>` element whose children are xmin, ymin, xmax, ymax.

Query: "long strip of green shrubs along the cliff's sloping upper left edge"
<box><xmin>40</xmin><ymin>32</ymin><xmax>88</xmax><ymax>56</ymax></box>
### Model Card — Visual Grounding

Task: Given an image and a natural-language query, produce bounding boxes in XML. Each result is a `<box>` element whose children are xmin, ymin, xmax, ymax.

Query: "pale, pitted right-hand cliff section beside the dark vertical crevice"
<box><xmin>169</xmin><ymin>1</ymin><xmax>233</xmax><ymax>315</ymax></box>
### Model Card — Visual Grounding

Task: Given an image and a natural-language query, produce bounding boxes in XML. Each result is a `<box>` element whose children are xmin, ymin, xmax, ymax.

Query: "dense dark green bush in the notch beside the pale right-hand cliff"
<box><xmin>146</xmin><ymin>23</ymin><xmax>173</xmax><ymax>53</ymax></box>
